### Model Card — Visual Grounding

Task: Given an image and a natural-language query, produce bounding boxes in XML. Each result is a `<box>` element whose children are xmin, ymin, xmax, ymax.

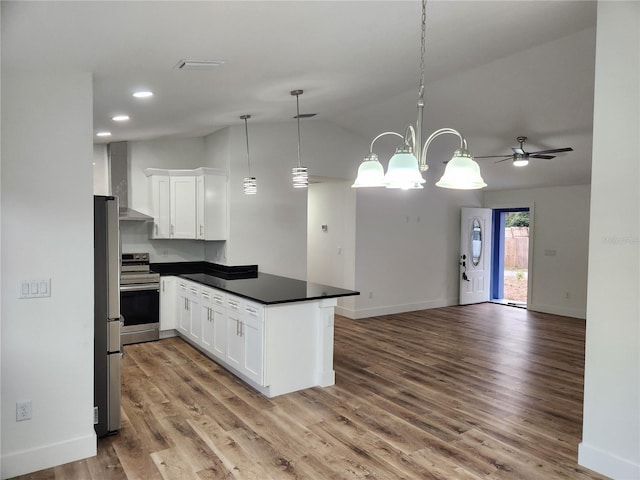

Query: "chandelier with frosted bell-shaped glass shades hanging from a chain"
<box><xmin>351</xmin><ymin>0</ymin><xmax>487</xmax><ymax>190</ymax></box>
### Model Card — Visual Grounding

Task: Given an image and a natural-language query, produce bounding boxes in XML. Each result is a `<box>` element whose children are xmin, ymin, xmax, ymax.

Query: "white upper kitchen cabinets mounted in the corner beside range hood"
<box><xmin>145</xmin><ymin>168</ymin><xmax>227</xmax><ymax>240</ymax></box>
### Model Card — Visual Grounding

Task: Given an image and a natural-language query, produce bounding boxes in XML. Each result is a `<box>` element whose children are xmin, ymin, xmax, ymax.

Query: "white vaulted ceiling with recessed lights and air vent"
<box><xmin>2</xmin><ymin>0</ymin><xmax>596</xmax><ymax>189</ymax></box>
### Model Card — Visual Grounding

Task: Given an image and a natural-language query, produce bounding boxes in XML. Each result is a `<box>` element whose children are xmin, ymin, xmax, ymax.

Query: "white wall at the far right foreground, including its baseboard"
<box><xmin>578</xmin><ymin>2</ymin><xmax>640</xmax><ymax>479</ymax></box>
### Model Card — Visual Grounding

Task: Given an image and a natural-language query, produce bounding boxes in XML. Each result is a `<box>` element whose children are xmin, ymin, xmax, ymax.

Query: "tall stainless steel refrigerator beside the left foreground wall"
<box><xmin>93</xmin><ymin>196</ymin><xmax>122</xmax><ymax>437</ymax></box>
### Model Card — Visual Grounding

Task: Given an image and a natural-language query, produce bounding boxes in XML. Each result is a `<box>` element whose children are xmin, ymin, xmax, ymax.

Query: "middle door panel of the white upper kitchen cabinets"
<box><xmin>170</xmin><ymin>176</ymin><xmax>196</xmax><ymax>239</ymax></box>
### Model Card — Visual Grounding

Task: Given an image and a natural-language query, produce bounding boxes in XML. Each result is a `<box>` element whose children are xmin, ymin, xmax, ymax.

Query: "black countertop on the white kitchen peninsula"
<box><xmin>151</xmin><ymin>262</ymin><xmax>360</xmax><ymax>305</ymax></box>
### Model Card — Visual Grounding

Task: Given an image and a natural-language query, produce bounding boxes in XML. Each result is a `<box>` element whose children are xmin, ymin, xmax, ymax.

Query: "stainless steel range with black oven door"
<box><xmin>120</xmin><ymin>253</ymin><xmax>160</xmax><ymax>345</ymax></box>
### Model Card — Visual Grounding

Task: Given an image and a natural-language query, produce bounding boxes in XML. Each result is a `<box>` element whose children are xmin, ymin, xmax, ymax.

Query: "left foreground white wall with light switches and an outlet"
<box><xmin>0</xmin><ymin>71</ymin><xmax>96</xmax><ymax>478</ymax></box>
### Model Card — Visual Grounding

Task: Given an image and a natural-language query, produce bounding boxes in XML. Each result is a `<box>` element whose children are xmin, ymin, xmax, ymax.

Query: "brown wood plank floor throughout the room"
<box><xmin>11</xmin><ymin>304</ymin><xmax>605</xmax><ymax>480</ymax></box>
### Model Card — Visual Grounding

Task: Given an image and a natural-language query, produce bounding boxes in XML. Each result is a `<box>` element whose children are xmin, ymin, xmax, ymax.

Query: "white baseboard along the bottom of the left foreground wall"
<box><xmin>1</xmin><ymin>432</ymin><xmax>98</xmax><ymax>479</ymax></box>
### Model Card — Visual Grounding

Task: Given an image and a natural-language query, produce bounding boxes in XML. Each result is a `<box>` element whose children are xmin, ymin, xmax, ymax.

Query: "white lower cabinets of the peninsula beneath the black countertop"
<box><xmin>170</xmin><ymin>278</ymin><xmax>336</xmax><ymax>397</ymax></box>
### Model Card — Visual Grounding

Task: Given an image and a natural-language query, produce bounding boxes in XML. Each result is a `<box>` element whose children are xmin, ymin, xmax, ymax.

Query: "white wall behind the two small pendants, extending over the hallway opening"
<box><xmin>205</xmin><ymin>120</ymin><xmax>366</xmax><ymax>280</ymax></box>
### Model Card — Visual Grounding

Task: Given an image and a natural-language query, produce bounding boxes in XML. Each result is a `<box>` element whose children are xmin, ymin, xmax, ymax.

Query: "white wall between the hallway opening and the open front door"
<box><xmin>355</xmin><ymin>185</ymin><xmax>482</xmax><ymax>318</ymax></box>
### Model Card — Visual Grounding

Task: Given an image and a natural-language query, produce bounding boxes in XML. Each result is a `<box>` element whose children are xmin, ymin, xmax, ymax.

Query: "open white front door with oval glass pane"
<box><xmin>460</xmin><ymin>208</ymin><xmax>491</xmax><ymax>305</ymax></box>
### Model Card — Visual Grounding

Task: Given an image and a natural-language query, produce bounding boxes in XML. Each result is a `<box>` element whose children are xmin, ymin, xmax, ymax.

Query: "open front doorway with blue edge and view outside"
<box><xmin>490</xmin><ymin>207</ymin><xmax>532</xmax><ymax>308</ymax></box>
